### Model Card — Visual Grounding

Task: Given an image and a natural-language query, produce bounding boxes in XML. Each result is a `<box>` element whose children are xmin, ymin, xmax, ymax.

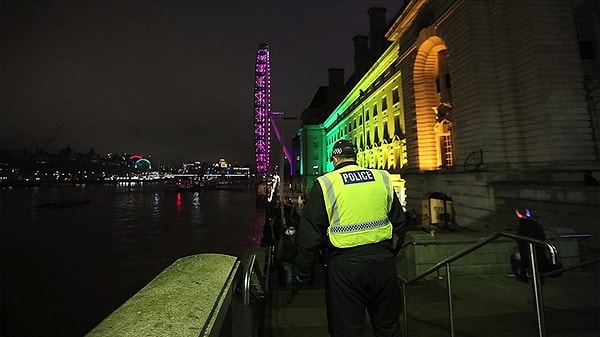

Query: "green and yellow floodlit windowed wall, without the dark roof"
<box><xmin>320</xmin><ymin>38</ymin><xmax>407</xmax><ymax>179</ymax></box>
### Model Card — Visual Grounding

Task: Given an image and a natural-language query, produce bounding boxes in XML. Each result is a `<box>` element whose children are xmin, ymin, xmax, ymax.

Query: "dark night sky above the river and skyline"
<box><xmin>0</xmin><ymin>0</ymin><xmax>402</xmax><ymax>165</ymax></box>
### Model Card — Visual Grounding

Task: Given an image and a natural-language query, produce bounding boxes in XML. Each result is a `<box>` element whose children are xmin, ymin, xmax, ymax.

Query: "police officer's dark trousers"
<box><xmin>327</xmin><ymin>253</ymin><xmax>402</xmax><ymax>337</ymax></box>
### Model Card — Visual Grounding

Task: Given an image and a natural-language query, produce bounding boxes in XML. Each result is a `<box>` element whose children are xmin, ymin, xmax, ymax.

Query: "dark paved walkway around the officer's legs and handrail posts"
<box><xmin>271</xmin><ymin>269</ymin><xmax>600</xmax><ymax>337</ymax></box>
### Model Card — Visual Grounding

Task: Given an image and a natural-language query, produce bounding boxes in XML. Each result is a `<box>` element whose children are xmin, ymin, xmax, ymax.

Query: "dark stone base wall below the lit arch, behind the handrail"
<box><xmin>402</xmin><ymin>172</ymin><xmax>600</xmax><ymax>250</ymax></box>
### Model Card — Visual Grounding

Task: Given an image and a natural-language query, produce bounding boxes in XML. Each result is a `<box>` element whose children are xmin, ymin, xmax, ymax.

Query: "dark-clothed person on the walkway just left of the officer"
<box><xmin>277</xmin><ymin>224</ymin><xmax>298</xmax><ymax>304</ymax></box>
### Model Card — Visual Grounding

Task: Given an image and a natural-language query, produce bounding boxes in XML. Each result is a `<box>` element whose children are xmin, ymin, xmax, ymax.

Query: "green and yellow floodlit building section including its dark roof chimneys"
<box><xmin>299</xmin><ymin>8</ymin><xmax>406</xmax><ymax>195</ymax></box>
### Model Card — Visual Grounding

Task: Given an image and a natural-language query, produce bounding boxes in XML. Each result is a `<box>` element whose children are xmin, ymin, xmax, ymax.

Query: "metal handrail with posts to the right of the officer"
<box><xmin>398</xmin><ymin>232</ymin><xmax>558</xmax><ymax>337</ymax></box>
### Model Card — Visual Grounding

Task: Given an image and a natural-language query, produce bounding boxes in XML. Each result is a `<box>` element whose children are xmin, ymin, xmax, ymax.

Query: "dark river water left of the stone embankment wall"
<box><xmin>0</xmin><ymin>183</ymin><xmax>264</xmax><ymax>337</ymax></box>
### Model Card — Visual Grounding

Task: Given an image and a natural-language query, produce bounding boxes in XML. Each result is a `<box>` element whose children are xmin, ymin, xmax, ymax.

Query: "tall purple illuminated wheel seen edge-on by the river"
<box><xmin>254</xmin><ymin>43</ymin><xmax>271</xmax><ymax>174</ymax></box>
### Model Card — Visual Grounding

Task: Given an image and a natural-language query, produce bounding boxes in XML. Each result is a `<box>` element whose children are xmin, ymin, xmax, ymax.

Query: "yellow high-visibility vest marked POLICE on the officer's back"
<box><xmin>317</xmin><ymin>165</ymin><xmax>394</xmax><ymax>248</ymax></box>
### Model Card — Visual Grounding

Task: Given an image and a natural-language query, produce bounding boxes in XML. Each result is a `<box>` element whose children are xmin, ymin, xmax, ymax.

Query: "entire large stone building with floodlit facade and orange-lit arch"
<box><xmin>299</xmin><ymin>0</ymin><xmax>600</xmax><ymax>247</ymax></box>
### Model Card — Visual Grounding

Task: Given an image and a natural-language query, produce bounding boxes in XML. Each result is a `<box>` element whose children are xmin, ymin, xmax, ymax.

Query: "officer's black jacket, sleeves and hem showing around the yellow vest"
<box><xmin>296</xmin><ymin>162</ymin><xmax>406</xmax><ymax>276</ymax></box>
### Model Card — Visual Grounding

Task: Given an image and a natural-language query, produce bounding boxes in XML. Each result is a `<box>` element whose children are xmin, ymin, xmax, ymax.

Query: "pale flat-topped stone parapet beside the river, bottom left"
<box><xmin>86</xmin><ymin>254</ymin><xmax>241</xmax><ymax>337</ymax></box>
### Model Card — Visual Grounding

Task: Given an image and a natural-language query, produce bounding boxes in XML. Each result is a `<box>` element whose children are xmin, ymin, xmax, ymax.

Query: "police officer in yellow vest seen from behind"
<box><xmin>296</xmin><ymin>140</ymin><xmax>406</xmax><ymax>337</ymax></box>
